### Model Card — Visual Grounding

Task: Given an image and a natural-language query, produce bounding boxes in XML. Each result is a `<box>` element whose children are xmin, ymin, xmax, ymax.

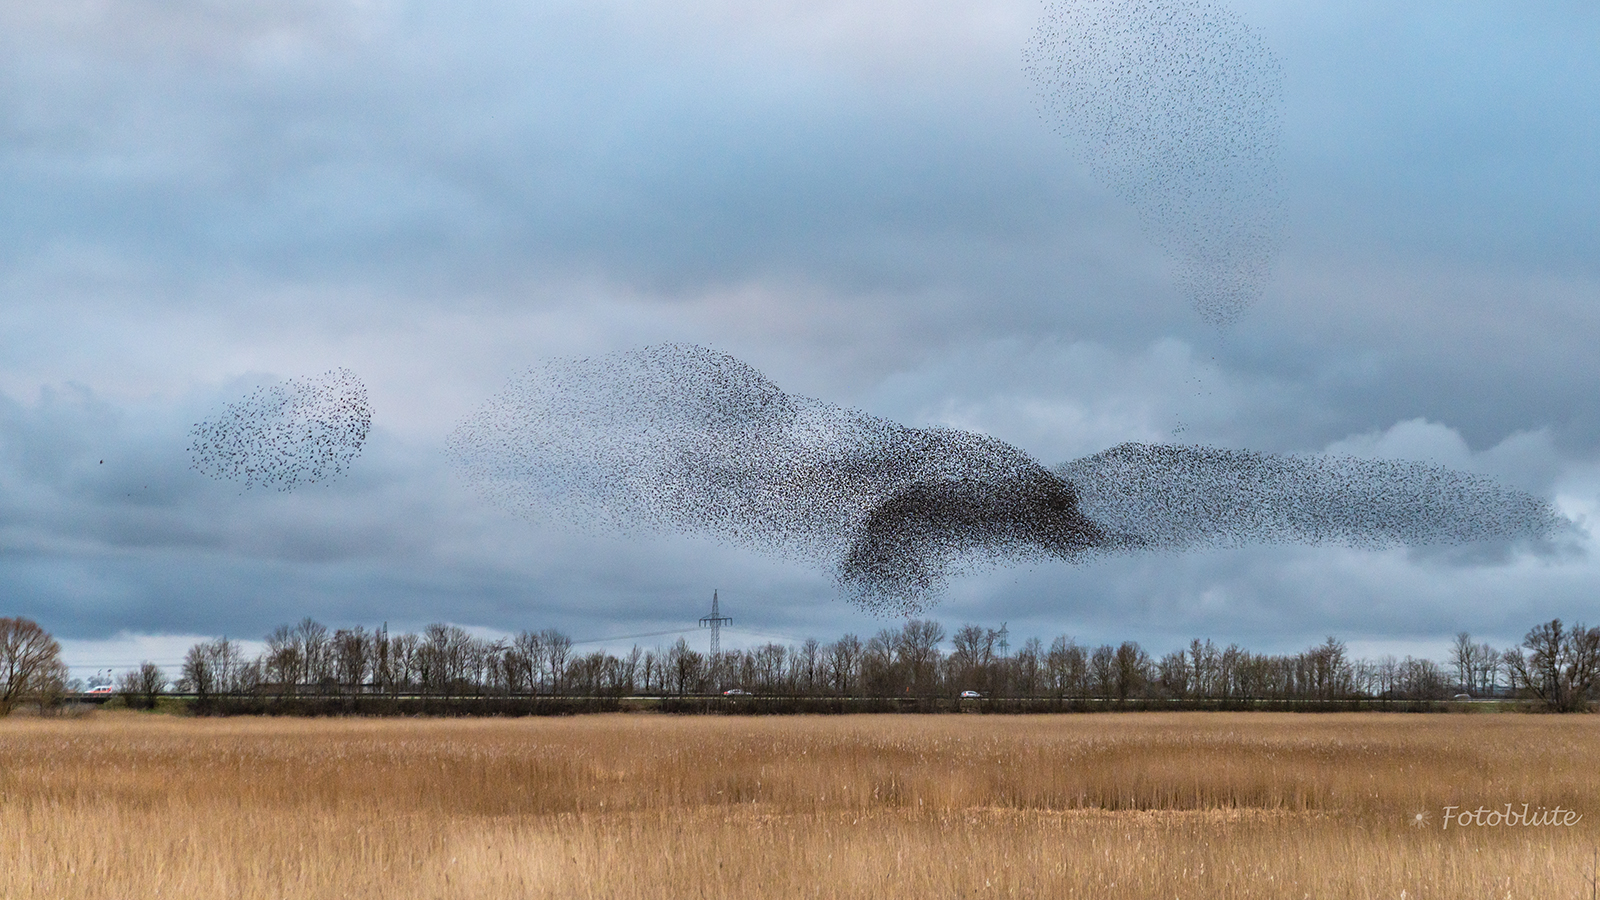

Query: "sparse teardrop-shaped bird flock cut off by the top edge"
<box><xmin>1024</xmin><ymin>0</ymin><xmax>1283</xmax><ymax>325</ymax></box>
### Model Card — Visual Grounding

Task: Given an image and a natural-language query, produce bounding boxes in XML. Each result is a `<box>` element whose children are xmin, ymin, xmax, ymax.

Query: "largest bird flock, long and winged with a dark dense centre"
<box><xmin>448</xmin><ymin>344</ymin><xmax>1562</xmax><ymax>615</ymax></box>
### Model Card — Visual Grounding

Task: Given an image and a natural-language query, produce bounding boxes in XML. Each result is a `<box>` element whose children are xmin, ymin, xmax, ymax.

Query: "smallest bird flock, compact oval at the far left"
<box><xmin>189</xmin><ymin>368</ymin><xmax>373</xmax><ymax>490</ymax></box>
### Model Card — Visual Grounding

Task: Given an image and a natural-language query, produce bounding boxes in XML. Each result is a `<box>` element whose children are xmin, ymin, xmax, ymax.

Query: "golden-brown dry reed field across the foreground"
<box><xmin>0</xmin><ymin>713</ymin><xmax>1600</xmax><ymax>900</ymax></box>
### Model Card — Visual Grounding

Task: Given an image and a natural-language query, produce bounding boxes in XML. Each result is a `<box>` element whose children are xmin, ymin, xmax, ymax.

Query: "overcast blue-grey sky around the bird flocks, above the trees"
<box><xmin>0</xmin><ymin>0</ymin><xmax>1600</xmax><ymax>665</ymax></box>
